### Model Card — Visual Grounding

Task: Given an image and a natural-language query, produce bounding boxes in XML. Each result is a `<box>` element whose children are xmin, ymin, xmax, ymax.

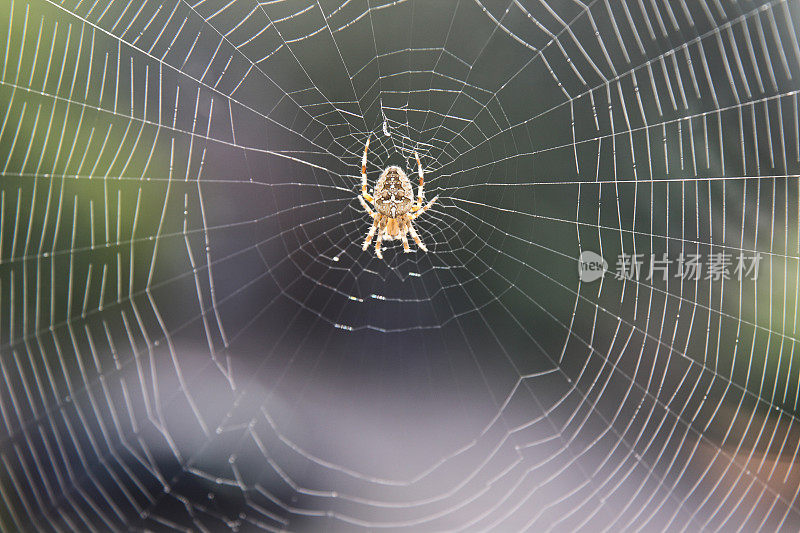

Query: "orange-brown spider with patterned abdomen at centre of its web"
<box><xmin>358</xmin><ymin>137</ymin><xmax>439</xmax><ymax>259</ymax></box>
